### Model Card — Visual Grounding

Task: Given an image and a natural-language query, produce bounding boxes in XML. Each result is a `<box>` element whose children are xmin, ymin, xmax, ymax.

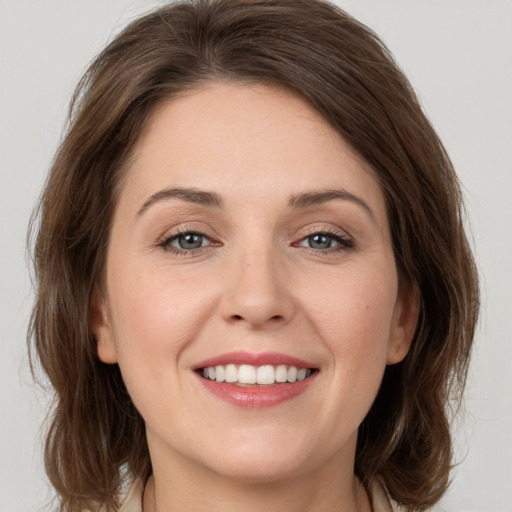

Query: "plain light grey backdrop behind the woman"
<box><xmin>0</xmin><ymin>0</ymin><xmax>512</xmax><ymax>512</ymax></box>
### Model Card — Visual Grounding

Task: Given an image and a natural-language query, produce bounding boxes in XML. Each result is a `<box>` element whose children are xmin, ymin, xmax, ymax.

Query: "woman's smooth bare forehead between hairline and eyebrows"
<box><xmin>118</xmin><ymin>82</ymin><xmax>384</xmax><ymax>220</ymax></box>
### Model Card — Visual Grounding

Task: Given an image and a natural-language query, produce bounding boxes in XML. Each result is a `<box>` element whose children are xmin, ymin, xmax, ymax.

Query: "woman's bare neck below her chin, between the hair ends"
<box><xmin>143</xmin><ymin>438</ymin><xmax>372</xmax><ymax>512</ymax></box>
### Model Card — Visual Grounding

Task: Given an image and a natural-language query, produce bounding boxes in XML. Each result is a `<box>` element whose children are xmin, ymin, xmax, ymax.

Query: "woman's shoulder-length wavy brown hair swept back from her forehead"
<box><xmin>29</xmin><ymin>0</ymin><xmax>478</xmax><ymax>511</ymax></box>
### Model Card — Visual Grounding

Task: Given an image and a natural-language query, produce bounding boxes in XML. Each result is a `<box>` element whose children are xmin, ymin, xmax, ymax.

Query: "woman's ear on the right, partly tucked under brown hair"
<box><xmin>386</xmin><ymin>285</ymin><xmax>420</xmax><ymax>364</ymax></box>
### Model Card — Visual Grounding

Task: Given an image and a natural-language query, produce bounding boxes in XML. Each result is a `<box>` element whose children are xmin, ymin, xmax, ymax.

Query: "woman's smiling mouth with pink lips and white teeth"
<box><xmin>193</xmin><ymin>352</ymin><xmax>320</xmax><ymax>408</ymax></box>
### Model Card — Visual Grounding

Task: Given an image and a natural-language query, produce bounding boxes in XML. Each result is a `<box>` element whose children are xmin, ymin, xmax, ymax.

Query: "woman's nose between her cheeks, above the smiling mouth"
<box><xmin>221</xmin><ymin>249</ymin><xmax>295</xmax><ymax>330</ymax></box>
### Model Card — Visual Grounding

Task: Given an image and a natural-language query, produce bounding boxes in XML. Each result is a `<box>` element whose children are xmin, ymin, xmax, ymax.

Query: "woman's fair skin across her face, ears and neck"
<box><xmin>93</xmin><ymin>82</ymin><xmax>418</xmax><ymax>512</ymax></box>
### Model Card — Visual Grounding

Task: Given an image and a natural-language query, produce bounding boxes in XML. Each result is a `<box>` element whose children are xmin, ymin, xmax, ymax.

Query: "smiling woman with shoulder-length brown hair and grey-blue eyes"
<box><xmin>32</xmin><ymin>0</ymin><xmax>478</xmax><ymax>512</ymax></box>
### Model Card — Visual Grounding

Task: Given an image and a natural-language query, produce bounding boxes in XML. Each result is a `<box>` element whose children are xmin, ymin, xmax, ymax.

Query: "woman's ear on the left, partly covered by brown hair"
<box><xmin>91</xmin><ymin>284</ymin><xmax>117</xmax><ymax>364</ymax></box>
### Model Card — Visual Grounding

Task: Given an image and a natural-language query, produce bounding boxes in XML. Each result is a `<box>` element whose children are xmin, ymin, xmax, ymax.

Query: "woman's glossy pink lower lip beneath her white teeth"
<box><xmin>198</xmin><ymin>372</ymin><xmax>318</xmax><ymax>409</ymax></box>
